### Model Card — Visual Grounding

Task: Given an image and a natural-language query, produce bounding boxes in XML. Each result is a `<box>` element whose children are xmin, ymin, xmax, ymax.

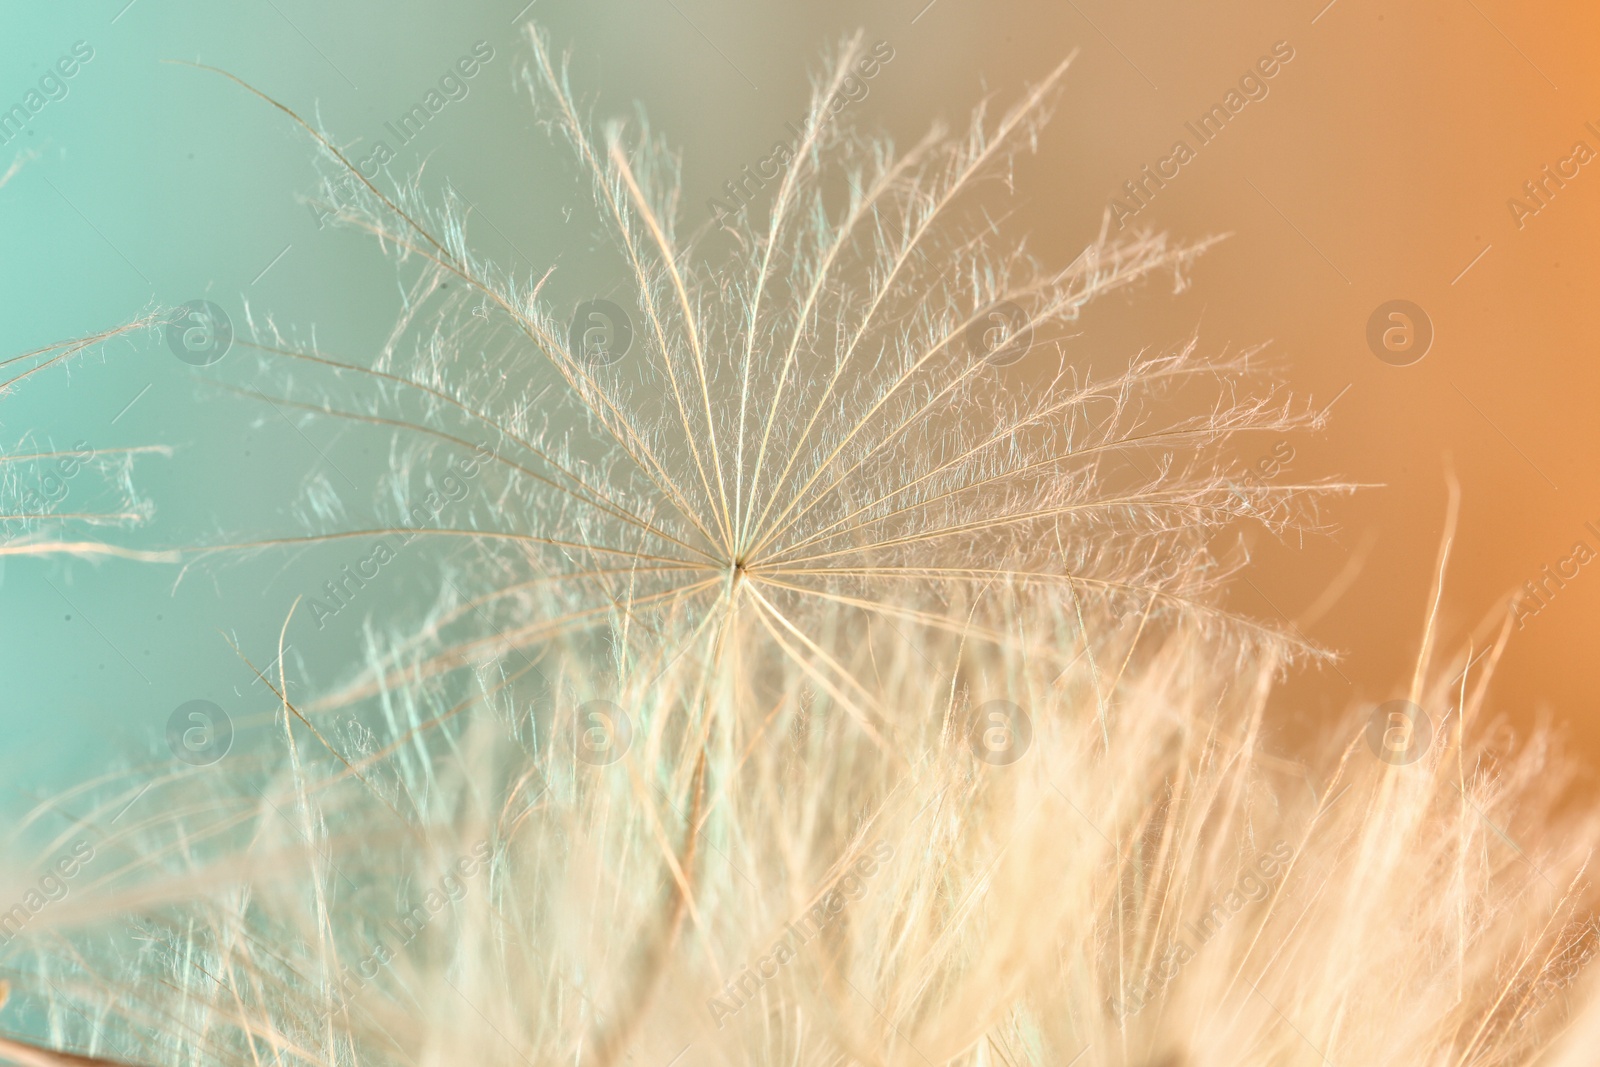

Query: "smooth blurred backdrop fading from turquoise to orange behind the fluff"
<box><xmin>0</xmin><ymin>0</ymin><xmax>1600</xmax><ymax>799</ymax></box>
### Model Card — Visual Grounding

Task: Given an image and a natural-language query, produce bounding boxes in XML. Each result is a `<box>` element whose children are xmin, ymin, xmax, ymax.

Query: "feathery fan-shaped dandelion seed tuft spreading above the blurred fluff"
<box><xmin>162</xmin><ymin>32</ymin><xmax>1338</xmax><ymax>729</ymax></box>
